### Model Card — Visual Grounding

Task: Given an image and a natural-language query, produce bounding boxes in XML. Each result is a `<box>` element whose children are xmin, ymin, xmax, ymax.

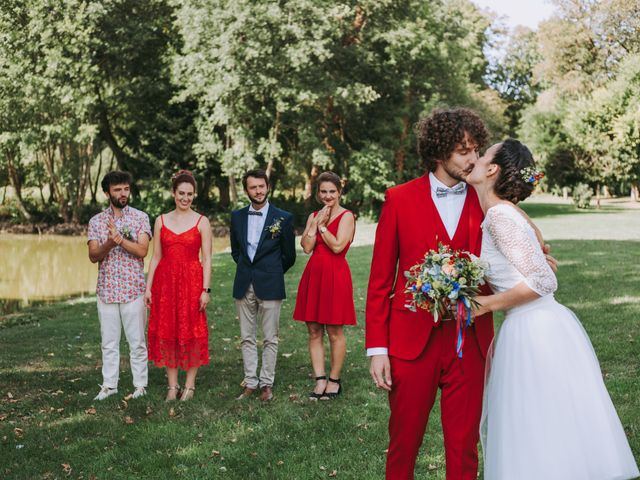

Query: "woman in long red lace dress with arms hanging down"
<box><xmin>144</xmin><ymin>170</ymin><xmax>211</xmax><ymax>401</ymax></box>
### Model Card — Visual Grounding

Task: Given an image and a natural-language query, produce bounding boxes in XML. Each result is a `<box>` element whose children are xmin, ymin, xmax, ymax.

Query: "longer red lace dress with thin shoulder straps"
<box><xmin>148</xmin><ymin>217</ymin><xmax>209</xmax><ymax>370</ymax></box>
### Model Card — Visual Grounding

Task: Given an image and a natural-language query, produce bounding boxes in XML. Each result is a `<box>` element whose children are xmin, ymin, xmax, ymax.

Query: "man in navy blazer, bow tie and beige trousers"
<box><xmin>231</xmin><ymin>169</ymin><xmax>296</xmax><ymax>401</ymax></box>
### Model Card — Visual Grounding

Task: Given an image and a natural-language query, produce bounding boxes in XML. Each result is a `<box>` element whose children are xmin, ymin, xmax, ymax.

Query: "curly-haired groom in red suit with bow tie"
<box><xmin>366</xmin><ymin>108</ymin><xmax>493</xmax><ymax>480</ymax></box>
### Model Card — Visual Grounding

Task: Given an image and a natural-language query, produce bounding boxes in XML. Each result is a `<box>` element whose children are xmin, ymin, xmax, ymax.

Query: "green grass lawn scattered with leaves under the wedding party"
<box><xmin>0</xmin><ymin>241</ymin><xmax>640</xmax><ymax>480</ymax></box>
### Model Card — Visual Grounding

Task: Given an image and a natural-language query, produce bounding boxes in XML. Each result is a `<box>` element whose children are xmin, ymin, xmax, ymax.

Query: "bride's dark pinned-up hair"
<box><xmin>491</xmin><ymin>138</ymin><xmax>536</xmax><ymax>203</ymax></box>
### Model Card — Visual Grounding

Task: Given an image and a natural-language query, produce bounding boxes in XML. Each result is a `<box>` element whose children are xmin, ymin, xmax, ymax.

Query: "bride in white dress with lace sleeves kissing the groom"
<box><xmin>467</xmin><ymin>140</ymin><xmax>640</xmax><ymax>480</ymax></box>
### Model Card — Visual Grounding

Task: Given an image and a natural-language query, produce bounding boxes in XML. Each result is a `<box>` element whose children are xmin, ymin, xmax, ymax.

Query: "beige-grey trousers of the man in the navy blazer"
<box><xmin>236</xmin><ymin>285</ymin><xmax>282</xmax><ymax>388</ymax></box>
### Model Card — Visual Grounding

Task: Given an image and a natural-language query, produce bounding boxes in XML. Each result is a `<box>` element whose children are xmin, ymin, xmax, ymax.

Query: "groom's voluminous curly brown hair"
<box><xmin>415</xmin><ymin>108</ymin><xmax>489</xmax><ymax>172</ymax></box>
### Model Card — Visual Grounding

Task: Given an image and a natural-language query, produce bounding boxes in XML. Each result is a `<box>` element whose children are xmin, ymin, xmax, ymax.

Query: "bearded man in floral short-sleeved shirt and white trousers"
<box><xmin>88</xmin><ymin>171</ymin><xmax>151</xmax><ymax>400</ymax></box>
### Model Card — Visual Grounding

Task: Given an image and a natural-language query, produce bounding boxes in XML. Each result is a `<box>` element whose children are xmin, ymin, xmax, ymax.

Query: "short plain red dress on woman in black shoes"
<box><xmin>293</xmin><ymin>210</ymin><xmax>356</xmax><ymax>325</ymax></box>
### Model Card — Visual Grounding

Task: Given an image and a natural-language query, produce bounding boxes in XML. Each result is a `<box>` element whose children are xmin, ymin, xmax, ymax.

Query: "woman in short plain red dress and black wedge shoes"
<box><xmin>293</xmin><ymin>172</ymin><xmax>356</xmax><ymax>400</ymax></box>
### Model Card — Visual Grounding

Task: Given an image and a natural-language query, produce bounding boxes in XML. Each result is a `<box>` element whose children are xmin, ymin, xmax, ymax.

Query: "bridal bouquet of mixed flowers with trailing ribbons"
<box><xmin>404</xmin><ymin>243</ymin><xmax>487</xmax><ymax>357</ymax></box>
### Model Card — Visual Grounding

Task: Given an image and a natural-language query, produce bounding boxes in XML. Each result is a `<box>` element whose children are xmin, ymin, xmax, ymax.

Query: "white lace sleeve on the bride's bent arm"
<box><xmin>485</xmin><ymin>206</ymin><xmax>558</xmax><ymax>296</ymax></box>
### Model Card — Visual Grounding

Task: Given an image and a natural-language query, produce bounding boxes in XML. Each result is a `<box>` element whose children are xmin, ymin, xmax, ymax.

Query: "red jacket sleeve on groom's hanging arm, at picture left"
<box><xmin>365</xmin><ymin>189</ymin><xmax>399</xmax><ymax>348</ymax></box>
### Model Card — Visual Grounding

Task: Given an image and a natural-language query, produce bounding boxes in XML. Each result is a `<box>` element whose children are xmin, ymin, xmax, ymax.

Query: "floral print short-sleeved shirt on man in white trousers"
<box><xmin>88</xmin><ymin>205</ymin><xmax>151</xmax><ymax>303</ymax></box>
